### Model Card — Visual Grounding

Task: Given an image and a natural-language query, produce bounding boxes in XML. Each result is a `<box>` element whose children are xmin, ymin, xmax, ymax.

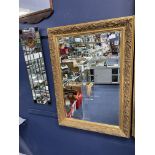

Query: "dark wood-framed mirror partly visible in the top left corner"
<box><xmin>19</xmin><ymin>0</ymin><xmax>54</xmax><ymax>24</ymax></box>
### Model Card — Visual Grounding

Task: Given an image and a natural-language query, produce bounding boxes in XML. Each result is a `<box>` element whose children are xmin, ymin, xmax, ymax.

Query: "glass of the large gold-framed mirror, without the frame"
<box><xmin>58</xmin><ymin>31</ymin><xmax>121</xmax><ymax>125</ymax></box>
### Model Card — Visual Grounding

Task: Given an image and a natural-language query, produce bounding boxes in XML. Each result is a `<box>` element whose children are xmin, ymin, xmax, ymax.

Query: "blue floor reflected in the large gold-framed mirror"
<box><xmin>73</xmin><ymin>85</ymin><xmax>119</xmax><ymax>125</ymax></box>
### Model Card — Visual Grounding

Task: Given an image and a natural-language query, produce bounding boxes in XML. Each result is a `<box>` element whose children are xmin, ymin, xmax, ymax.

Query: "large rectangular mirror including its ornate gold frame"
<box><xmin>48</xmin><ymin>16</ymin><xmax>134</xmax><ymax>138</ymax></box>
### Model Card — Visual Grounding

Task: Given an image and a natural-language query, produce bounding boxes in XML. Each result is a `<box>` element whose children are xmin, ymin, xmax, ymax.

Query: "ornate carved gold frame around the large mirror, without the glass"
<box><xmin>48</xmin><ymin>16</ymin><xmax>134</xmax><ymax>138</ymax></box>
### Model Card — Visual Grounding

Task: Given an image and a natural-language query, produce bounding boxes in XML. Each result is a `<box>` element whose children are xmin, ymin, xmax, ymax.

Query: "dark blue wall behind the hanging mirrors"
<box><xmin>19</xmin><ymin>0</ymin><xmax>135</xmax><ymax>155</ymax></box>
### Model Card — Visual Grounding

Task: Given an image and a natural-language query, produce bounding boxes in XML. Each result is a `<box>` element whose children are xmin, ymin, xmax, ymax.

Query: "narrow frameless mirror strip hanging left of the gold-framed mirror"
<box><xmin>20</xmin><ymin>28</ymin><xmax>50</xmax><ymax>104</ymax></box>
